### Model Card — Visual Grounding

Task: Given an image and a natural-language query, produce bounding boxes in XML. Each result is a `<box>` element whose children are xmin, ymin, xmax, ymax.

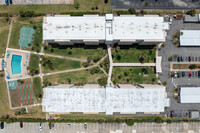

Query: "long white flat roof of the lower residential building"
<box><xmin>42</xmin><ymin>87</ymin><xmax>169</xmax><ymax>115</ymax></box>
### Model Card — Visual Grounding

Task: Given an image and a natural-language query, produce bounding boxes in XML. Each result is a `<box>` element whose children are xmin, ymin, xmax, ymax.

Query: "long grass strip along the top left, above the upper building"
<box><xmin>0</xmin><ymin>0</ymin><xmax>110</xmax><ymax>14</ymax></box>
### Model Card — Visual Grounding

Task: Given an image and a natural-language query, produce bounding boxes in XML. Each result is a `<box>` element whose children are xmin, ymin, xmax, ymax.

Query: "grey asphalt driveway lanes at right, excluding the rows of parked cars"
<box><xmin>159</xmin><ymin>17</ymin><xmax>200</xmax><ymax>116</ymax></box>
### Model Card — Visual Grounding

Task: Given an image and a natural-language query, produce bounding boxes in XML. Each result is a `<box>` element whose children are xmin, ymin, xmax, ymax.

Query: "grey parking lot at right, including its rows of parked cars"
<box><xmin>159</xmin><ymin>17</ymin><xmax>200</xmax><ymax>117</ymax></box>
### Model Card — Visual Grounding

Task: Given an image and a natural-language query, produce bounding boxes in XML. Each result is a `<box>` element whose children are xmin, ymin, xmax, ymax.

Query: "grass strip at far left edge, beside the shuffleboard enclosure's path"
<box><xmin>0</xmin><ymin>72</ymin><xmax>10</xmax><ymax>117</ymax></box>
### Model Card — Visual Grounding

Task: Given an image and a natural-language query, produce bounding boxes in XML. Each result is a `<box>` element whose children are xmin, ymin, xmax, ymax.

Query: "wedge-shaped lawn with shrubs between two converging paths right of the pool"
<box><xmin>41</xmin><ymin>56</ymin><xmax>81</xmax><ymax>73</ymax></box>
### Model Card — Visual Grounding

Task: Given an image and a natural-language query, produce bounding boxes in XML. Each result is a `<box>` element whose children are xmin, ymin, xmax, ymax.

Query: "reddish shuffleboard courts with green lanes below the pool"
<box><xmin>18</xmin><ymin>81</ymin><xmax>34</xmax><ymax>103</ymax></box>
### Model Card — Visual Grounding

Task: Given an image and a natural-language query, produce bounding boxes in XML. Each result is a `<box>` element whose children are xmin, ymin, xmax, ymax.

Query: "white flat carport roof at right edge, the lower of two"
<box><xmin>180</xmin><ymin>87</ymin><xmax>200</xmax><ymax>103</ymax></box>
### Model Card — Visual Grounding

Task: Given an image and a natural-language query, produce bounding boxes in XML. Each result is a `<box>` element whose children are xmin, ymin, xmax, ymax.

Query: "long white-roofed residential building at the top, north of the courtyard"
<box><xmin>43</xmin><ymin>14</ymin><xmax>169</xmax><ymax>45</ymax></box>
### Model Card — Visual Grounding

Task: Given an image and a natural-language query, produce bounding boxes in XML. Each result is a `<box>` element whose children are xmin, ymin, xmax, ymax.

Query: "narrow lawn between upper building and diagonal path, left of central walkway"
<box><xmin>44</xmin><ymin>48</ymin><xmax>105</xmax><ymax>59</ymax></box>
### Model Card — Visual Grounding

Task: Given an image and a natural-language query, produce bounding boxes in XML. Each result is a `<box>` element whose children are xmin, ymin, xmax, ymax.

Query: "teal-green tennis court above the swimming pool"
<box><xmin>19</xmin><ymin>27</ymin><xmax>35</xmax><ymax>48</ymax></box>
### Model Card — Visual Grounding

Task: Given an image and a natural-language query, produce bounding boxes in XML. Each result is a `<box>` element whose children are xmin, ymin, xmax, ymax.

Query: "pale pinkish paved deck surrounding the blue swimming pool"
<box><xmin>5</xmin><ymin>49</ymin><xmax>30</xmax><ymax>80</ymax></box>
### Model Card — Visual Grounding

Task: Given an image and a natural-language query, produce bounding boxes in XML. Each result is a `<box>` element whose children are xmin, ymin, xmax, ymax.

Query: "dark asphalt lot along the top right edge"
<box><xmin>111</xmin><ymin>0</ymin><xmax>200</xmax><ymax>9</ymax></box>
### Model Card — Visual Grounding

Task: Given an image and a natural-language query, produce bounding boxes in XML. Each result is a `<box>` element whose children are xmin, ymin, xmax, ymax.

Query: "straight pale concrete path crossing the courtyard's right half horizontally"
<box><xmin>112</xmin><ymin>63</ymin><xmax>156</xmax><ymax>67</ymax></box>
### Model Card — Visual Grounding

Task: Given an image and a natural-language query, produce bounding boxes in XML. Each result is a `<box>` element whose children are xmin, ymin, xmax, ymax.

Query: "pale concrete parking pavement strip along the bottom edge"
<box><xmin>0</xmin><ymin>122</ymin><xmax>200</xmax><ymax>133</ymax></box>
